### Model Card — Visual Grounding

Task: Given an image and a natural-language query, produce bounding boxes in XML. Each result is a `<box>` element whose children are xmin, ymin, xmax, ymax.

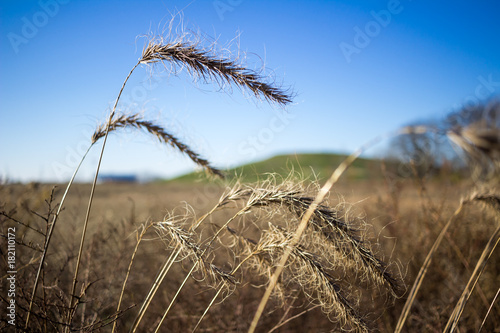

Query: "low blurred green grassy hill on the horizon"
<box><xmin>173</xmin><ymin>154</ymin><xmax>388</xmax><ymax>182</ymax></box>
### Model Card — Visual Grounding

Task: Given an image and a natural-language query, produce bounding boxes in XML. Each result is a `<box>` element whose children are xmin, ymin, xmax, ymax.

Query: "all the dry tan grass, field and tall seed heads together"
<box><xmin>0</xmin><ymin>21</ymin><xmax>500</xmax><ymax>332</ymax></box>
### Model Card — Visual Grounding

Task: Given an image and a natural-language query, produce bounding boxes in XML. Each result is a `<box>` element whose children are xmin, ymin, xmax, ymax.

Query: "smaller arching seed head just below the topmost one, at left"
<box><xmin>92</xmin><ymin>114</ymin><xmax>224</xmax><ymax>178</ymax></box>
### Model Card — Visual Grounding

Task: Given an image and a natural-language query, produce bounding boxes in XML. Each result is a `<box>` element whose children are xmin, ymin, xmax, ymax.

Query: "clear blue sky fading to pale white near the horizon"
<box><xmin>0</xmin><ymin>0</ymin><xmax>500</xmax><ymax>181</ymax></box>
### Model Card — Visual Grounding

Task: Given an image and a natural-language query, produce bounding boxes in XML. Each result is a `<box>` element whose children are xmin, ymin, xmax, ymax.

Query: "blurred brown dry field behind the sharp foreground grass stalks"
<box><xmin>0</xmin><ymin>175</ymin><xmax>500</xmax><ymax>332</ymax></box>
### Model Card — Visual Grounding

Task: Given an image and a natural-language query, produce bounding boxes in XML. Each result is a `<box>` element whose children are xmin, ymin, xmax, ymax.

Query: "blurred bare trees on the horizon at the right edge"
<box><xmin>385</xmin><ymin>98</ymin><xmax>500</xmax><ymax>178</ymax></box>
